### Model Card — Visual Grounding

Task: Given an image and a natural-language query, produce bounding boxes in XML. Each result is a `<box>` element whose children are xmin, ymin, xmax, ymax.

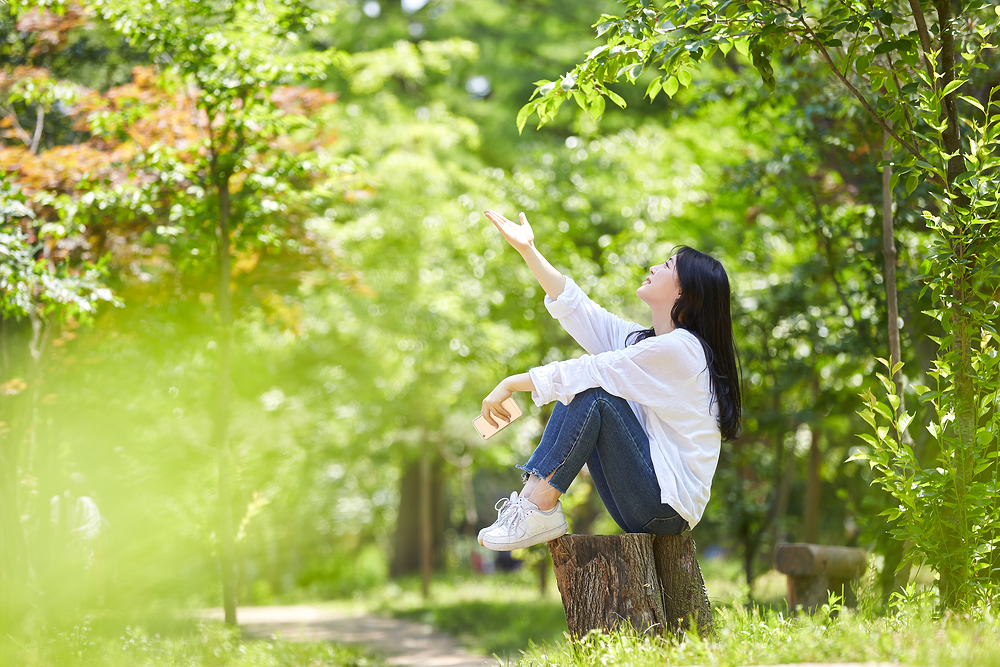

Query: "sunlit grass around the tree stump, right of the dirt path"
<box><xmin>346</xmin><ymin>560</ymin><xmax>1000</xmax><ymax>667</ymax></box>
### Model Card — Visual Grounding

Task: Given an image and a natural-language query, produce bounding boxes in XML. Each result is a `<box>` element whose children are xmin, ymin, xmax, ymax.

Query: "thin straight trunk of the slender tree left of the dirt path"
<box><xmin>212</xmin><ymin>160</ymin><xmax>236</xmax><ymax>625</ymax></box>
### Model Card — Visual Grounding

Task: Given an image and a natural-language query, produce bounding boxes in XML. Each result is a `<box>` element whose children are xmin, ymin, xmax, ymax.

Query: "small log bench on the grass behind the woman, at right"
<box><xmin>774</xmin><ymin>544</ymin><xmax>868</xmax><ymax>611</ymax></box>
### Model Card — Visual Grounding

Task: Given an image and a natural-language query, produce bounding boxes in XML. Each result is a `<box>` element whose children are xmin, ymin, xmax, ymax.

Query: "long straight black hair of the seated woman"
<box><xmin>625</xmin><ymin>246</ymin><xmax>743</xmax><ymax>441</ymax></box>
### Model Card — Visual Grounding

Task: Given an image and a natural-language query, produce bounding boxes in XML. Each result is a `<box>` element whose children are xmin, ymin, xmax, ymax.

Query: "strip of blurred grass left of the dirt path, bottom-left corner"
<box><xmin>0</xmin><ymin>621</ymin><xmax>381</xmax><ymax>667</ymax></box>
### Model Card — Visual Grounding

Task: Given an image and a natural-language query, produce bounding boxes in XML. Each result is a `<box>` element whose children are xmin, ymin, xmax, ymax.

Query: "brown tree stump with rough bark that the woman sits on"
<box><xmin>549</xmin><ymin>533</ymin><xmax>712</xmax><ymax>637</ymax></box>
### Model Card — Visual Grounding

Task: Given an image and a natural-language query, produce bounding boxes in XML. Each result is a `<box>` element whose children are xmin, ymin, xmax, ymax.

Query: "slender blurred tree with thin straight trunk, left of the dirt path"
<box><xmin>82</xmin><ymin>0</ymin><xmax>350</xmax><ymax>624</ymax></box>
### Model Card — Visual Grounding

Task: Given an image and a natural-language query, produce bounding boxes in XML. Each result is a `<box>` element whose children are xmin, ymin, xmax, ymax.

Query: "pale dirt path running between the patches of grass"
<box><xmin>195</xmin><ymin>605</ymin><xmax>497</xmax><ymax>667</ymax></box>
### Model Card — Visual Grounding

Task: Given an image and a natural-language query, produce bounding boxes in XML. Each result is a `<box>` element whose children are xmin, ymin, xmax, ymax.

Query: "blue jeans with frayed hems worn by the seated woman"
<box><xmin>517</xmin><ymin>388</ymin><xmax>688</xmax><ymax>535</ymax></box>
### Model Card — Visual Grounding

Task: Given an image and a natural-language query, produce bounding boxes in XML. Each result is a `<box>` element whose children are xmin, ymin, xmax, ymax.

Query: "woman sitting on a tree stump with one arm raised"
<box><xmin>479</xmin><ymin>211</ymin><xmax>741</xmax><ymax>551</ymax></box>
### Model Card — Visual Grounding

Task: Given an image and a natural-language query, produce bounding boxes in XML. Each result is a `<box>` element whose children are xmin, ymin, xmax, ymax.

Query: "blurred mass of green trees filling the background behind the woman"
<box><xmin>0</xmin><ymin>0</ymin><xmax>995</xmax><ymax>628</ymax></box>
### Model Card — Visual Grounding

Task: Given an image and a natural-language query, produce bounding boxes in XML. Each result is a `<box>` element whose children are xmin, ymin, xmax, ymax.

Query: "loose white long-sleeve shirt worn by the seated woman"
<box><xmin>528</xmin><ymin>276</ymin><xmax>722</xmax><ymax>528</ymax></box>
